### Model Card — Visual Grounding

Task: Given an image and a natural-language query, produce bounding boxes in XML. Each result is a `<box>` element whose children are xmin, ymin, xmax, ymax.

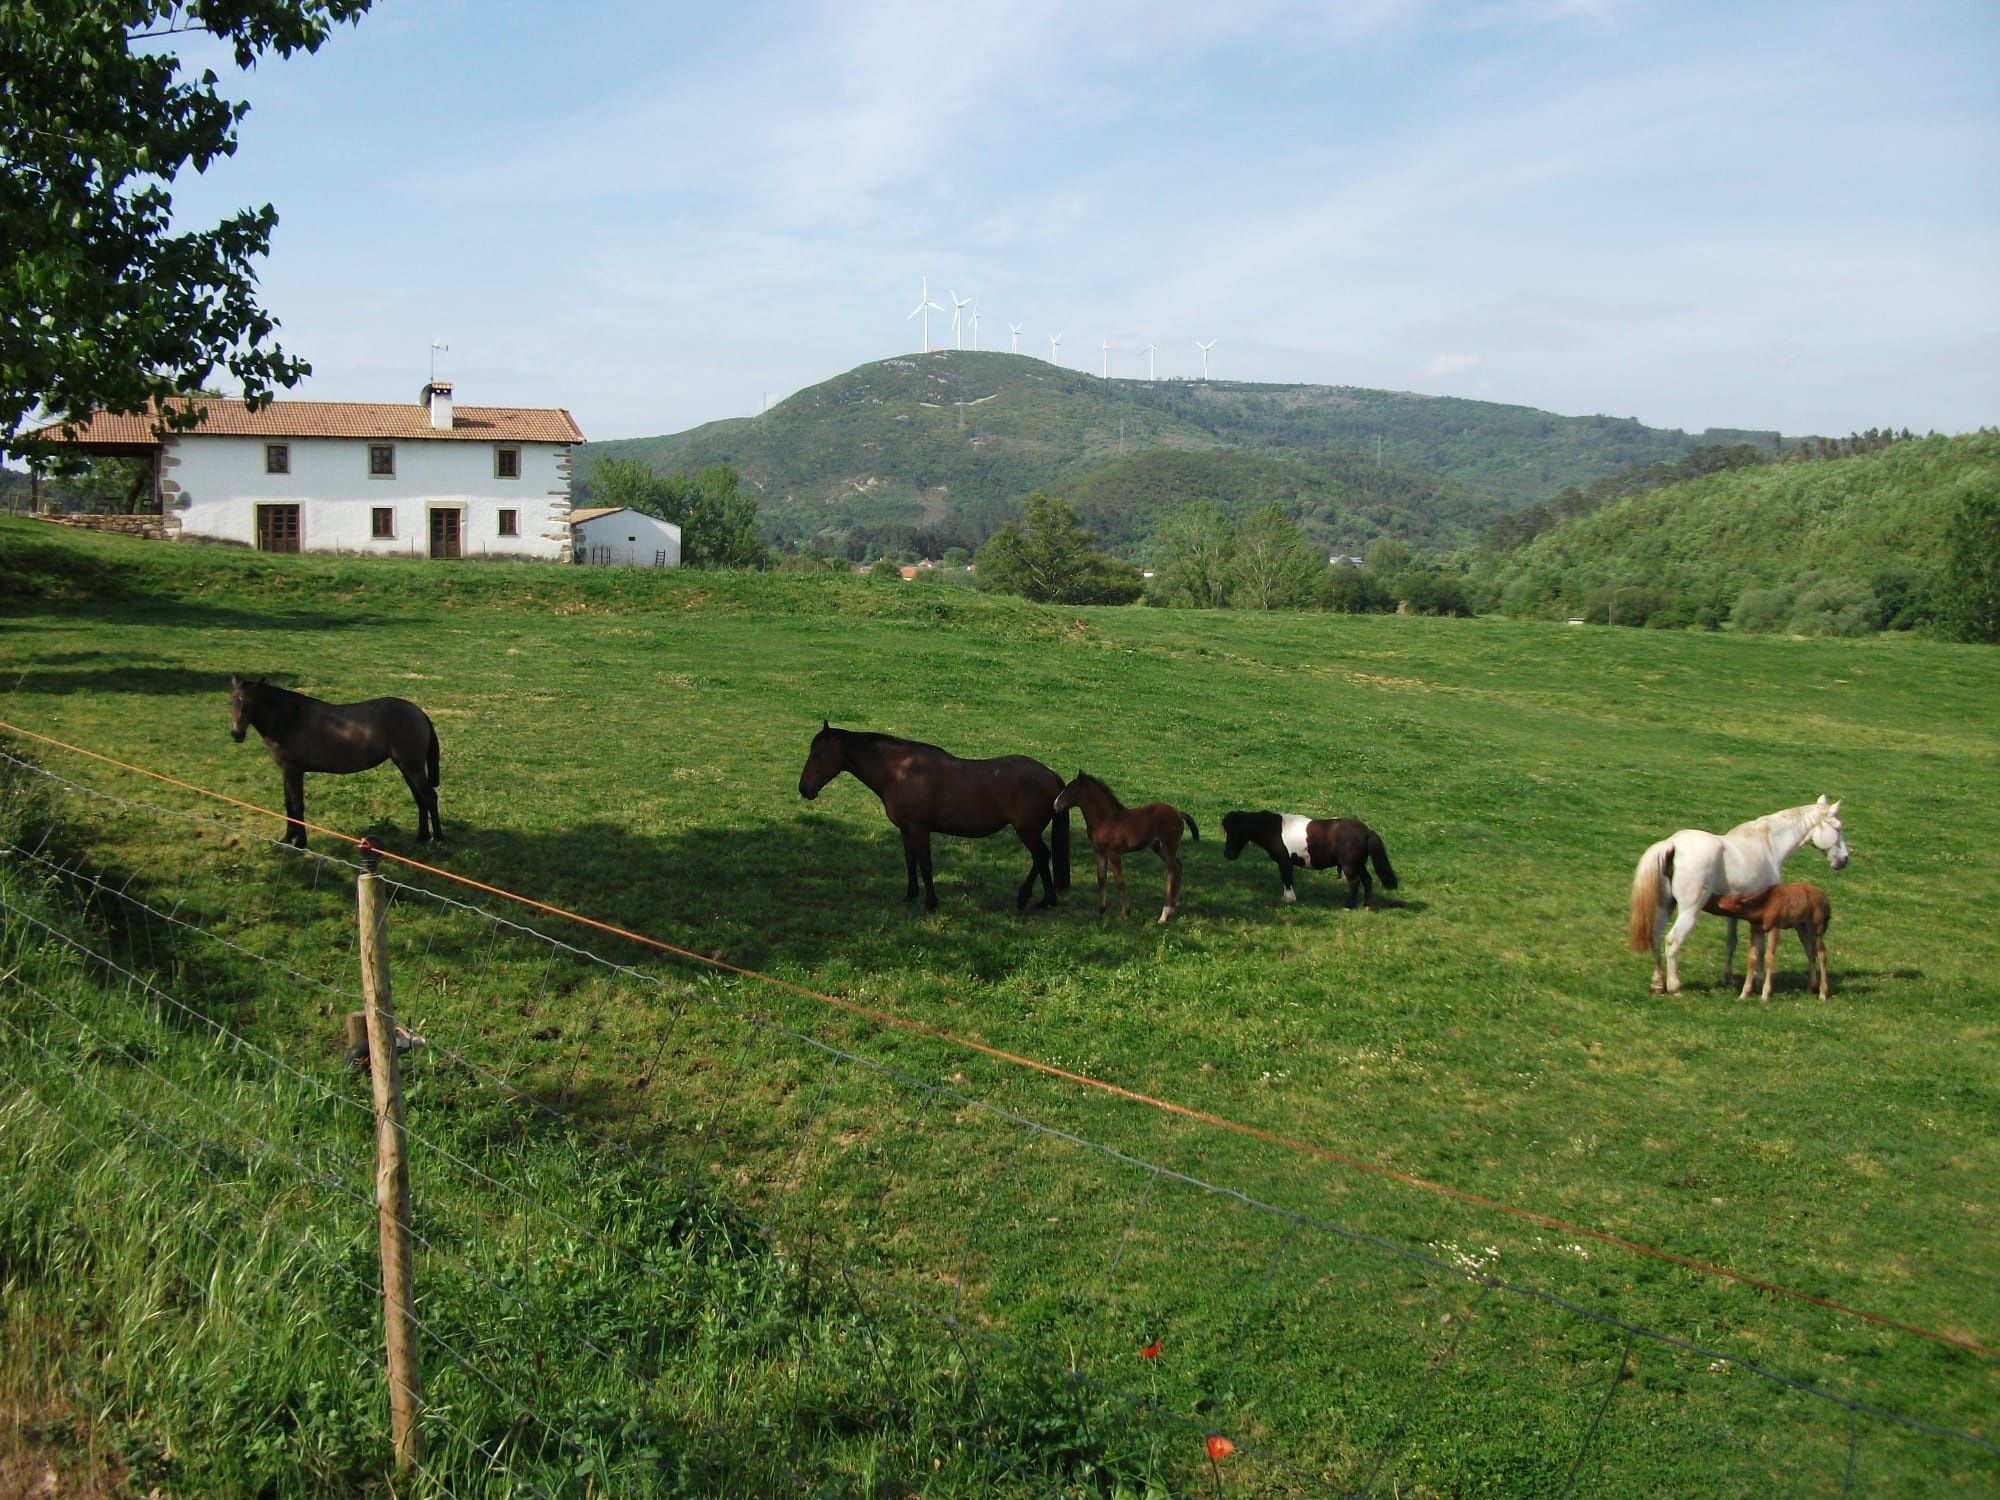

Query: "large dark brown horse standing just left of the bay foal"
<box><xmin>798</xmin><ymin>720</ymin><xmax>1070</xmax><ymax>912</ymax></box>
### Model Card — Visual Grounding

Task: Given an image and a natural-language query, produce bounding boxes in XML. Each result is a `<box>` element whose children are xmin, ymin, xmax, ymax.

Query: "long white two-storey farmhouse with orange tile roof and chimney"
<box><xmin>25</xmin><ymin>380</ymin><xmax>584</xmax><ymax>562</ymax></box>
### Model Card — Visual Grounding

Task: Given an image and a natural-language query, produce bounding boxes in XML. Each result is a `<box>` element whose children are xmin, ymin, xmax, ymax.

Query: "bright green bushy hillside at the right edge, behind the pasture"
<box><xmin>1476</xmin><ymin>432</ymin><xmax>2000</xmax><ymax>624</ymax></box>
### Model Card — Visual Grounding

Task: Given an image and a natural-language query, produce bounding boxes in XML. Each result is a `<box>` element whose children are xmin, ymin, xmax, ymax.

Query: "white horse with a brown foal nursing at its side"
<box><xmin>1632</xmin><ymin>796</ymin><xmax>1848</xmax><ymax>994</ymax></box>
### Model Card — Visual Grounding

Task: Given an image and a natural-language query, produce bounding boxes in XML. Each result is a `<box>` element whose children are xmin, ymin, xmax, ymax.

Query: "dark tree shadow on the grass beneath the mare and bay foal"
<box><xmin>320</xmin><ymin>812</ymin><xmax>1424</xmax><ymax>1000</ymax></box>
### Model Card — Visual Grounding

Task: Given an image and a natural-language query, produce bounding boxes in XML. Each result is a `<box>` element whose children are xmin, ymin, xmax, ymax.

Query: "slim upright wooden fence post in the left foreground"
<box><xmin>356</xmin><ymin>842</ymin><xmax>424</xmax><ymax>1472</ymax></box>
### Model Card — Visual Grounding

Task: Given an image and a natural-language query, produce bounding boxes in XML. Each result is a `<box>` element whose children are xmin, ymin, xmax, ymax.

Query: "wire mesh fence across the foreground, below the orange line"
<box><xmin>0</xmin><ymin>754</ymin><xmax>2000</xmax><ymax>1494</ymax></box>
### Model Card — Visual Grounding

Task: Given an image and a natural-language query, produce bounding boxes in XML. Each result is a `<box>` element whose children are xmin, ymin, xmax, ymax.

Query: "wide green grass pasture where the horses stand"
<box><xmin>0</xmin><ymin>522</ymin><xmax>2000</xmax><ymax>1494</ymax></box>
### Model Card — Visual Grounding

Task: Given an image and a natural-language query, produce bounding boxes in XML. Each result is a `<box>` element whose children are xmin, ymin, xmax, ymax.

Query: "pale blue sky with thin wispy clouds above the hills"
<box><xmin>160</xmin><ymin>0</ymin><xmax>2000</xmax><ymax>438</ymax></box>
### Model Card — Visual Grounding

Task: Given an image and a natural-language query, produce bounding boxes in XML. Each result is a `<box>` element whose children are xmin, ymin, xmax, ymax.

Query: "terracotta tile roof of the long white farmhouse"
<box><xmin>25</xmin><ymin>398</ymin><xmax>584</xmax><ymax>444</ymax></box>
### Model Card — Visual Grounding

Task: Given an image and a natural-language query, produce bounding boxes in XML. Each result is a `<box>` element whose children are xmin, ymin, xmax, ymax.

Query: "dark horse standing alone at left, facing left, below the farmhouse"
<box><xmin>230</xmin><ymin>678</ymin><xmax>444</xmax><ymax>848</ymax></box>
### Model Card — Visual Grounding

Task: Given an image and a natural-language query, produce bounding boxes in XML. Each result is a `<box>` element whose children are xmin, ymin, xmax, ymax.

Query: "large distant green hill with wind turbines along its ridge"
<box><xmin>576</xmin><ymin>350</ymin><xmax>1774</xmax><ymax>550</ymax></box>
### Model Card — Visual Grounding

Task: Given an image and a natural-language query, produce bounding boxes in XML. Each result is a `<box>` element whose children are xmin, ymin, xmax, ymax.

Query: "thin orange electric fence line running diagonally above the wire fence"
<box><xmin>0</xmin><ymin>720</ymin><xmax>2000</xmax><ymax>1360</ymax></box>
